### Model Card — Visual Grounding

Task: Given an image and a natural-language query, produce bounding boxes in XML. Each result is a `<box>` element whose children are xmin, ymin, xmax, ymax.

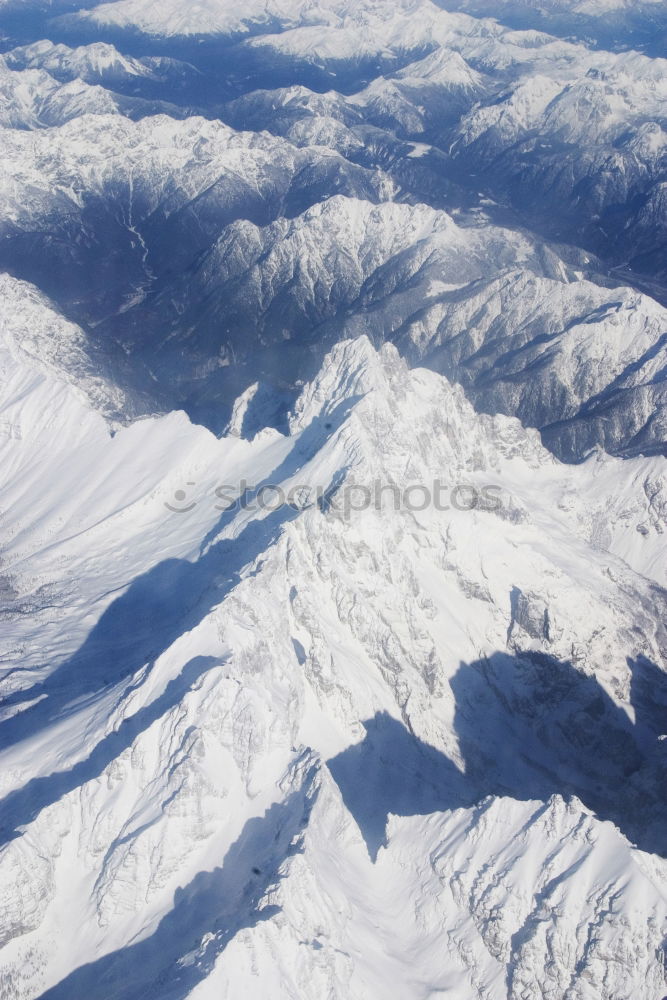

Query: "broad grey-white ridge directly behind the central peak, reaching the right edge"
<box><xmin>149</xmin><ymin>197</ymin><xmax>667</xmax><ymax>457</ymax></box>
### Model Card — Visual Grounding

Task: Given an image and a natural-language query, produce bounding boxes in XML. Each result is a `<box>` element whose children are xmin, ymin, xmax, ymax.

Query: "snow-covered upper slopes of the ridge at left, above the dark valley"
<box><xmin>0</xmin><ymin>114</ymin><xmax>390</xmax><ymax>243</ymax></box>
